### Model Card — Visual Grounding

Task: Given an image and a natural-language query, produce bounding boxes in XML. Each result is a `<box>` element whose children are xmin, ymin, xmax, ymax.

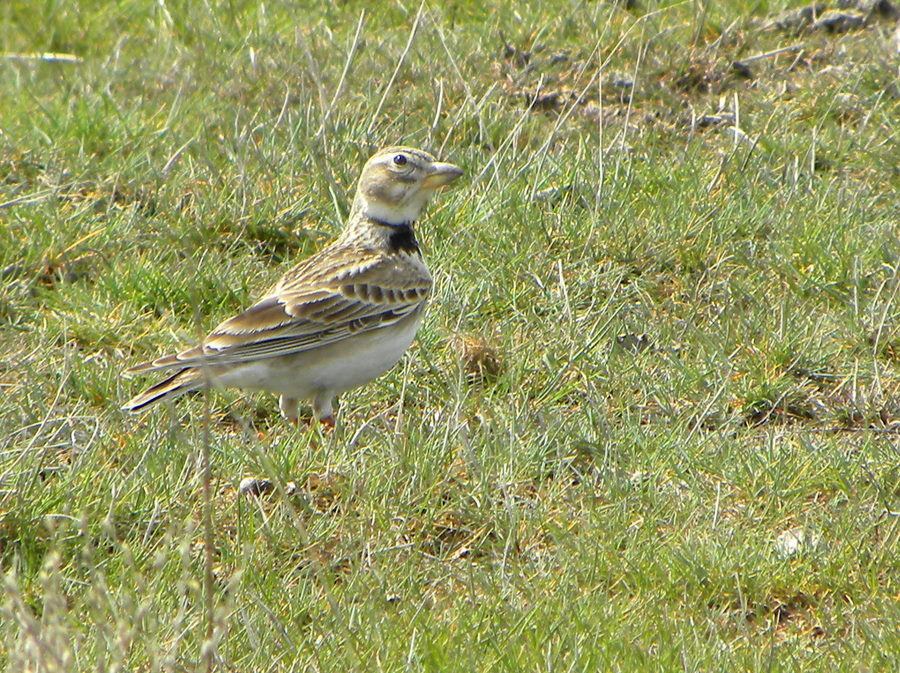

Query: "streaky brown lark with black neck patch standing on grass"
<box><xmin>122</xmin><ymin>146</ymin><xmax>463</xmax><ymax>428</ymax></box>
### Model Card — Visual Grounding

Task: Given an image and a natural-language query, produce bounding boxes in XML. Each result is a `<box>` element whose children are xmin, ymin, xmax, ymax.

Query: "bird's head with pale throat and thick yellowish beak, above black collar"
<box><xmin>353</xmin><ymin>147</ymin><xmax>462</xmax><ymax>224</ymax></box>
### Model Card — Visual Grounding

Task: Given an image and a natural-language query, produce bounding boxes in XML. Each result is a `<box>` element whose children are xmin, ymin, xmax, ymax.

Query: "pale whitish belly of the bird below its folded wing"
<box><xmin>216</xmin><ymin>312</ymin><xmax>422</xmax><ymax>399</ymax></box>
